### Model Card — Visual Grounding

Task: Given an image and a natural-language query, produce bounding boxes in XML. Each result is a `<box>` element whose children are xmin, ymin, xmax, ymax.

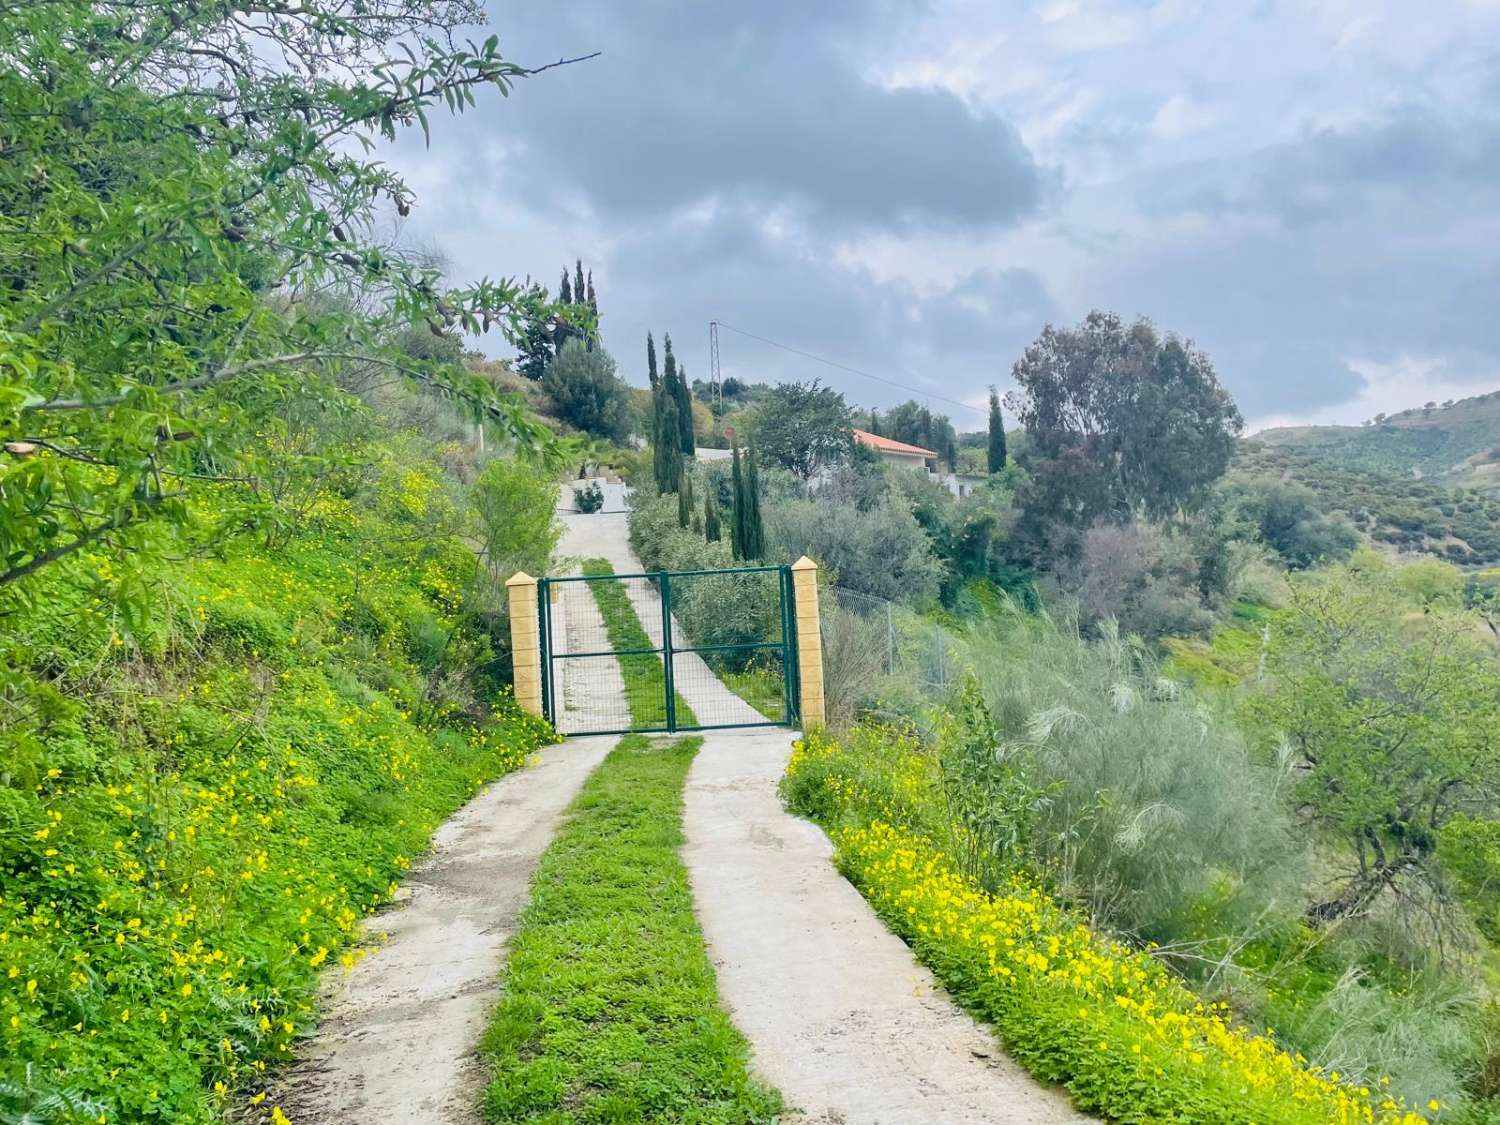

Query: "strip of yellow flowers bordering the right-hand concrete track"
<box><xmin>786</xmin><ymin>729</ymin><xmax>1442</xmax><ymax>1125</ymax></box>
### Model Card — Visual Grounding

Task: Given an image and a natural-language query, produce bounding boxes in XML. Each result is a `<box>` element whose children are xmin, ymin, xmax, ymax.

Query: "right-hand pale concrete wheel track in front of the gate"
<box><xmin>683</xmin><ymin>729</ymin><xmax>1089</xmax><ymax>1125</ymax></box>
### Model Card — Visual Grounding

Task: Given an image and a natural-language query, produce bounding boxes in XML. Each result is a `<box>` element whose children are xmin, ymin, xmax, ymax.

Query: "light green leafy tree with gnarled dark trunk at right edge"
<box><xmin>1244</xmin><ymin>552</ymin><xmax>1500</xmax><ymax>929</ymax></box>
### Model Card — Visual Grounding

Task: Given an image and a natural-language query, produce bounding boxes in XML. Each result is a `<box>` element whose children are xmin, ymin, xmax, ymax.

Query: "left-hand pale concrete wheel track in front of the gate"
<box><xmin>279</xmin><ymin>738</ymin><xmax>615</xmax><ymax>1125</ymax></box>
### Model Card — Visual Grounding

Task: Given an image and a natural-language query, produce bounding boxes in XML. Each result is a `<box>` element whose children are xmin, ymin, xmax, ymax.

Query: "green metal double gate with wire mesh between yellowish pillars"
<box><xmin>537</xmin><ymin>566</ymin><xmax>798</xmax><ymax>735</ymax></box>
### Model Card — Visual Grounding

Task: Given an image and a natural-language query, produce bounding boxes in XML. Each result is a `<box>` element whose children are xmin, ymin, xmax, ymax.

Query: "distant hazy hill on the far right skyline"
<box><xmin>1253</xmin><ymin>392</ymin><xmax>1500</xmax><ymax>491</ymax></box>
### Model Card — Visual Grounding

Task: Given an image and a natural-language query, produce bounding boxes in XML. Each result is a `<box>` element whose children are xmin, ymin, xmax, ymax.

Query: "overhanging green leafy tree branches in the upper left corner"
<box><xmin>0</xmin><ymin>0</ymin><xmax>558</xmax><ymax>617</ymax></box>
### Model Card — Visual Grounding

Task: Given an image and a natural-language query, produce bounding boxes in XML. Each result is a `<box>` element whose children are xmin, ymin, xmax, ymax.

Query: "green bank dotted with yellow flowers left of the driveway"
<box><xmin>0</xmin><ymin>441</ymin><xmax>549</xmax><ymax>1122</ymax></box>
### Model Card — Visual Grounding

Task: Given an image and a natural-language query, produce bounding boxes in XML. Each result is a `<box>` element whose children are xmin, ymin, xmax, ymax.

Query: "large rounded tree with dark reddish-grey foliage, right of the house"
<box><xmin>1010</xmin><ymin>311</ymin><xmax>1244</xmax><ymax>534</ymax></box>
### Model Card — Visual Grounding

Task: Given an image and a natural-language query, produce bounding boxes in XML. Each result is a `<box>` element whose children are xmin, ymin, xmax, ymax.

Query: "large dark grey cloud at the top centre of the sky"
<box><xmin>480</xmin><ymin>0</ymin><xmax>1046</xmax><ymax>228</ymax></box>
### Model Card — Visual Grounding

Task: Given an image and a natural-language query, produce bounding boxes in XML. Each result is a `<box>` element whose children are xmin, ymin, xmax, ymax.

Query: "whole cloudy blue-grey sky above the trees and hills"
<box><xmin>390</xmin><ymin>0</ymin><xmax>1500</xmax><ymax>429</ymax></box>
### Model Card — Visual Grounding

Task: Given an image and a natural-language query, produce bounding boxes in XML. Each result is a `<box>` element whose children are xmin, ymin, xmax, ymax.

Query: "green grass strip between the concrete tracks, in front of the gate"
<box><xmin>483</xmin><ymin>735</ymin><xmax>782</xmax><ymax>1125</ymax></box>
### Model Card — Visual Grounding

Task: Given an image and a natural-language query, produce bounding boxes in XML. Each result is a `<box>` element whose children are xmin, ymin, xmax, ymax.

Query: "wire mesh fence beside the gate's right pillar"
<box><xmin>822</xmin><ymin>587</ymin><xmax>971</xmax><ymax>726</ymax></box>
